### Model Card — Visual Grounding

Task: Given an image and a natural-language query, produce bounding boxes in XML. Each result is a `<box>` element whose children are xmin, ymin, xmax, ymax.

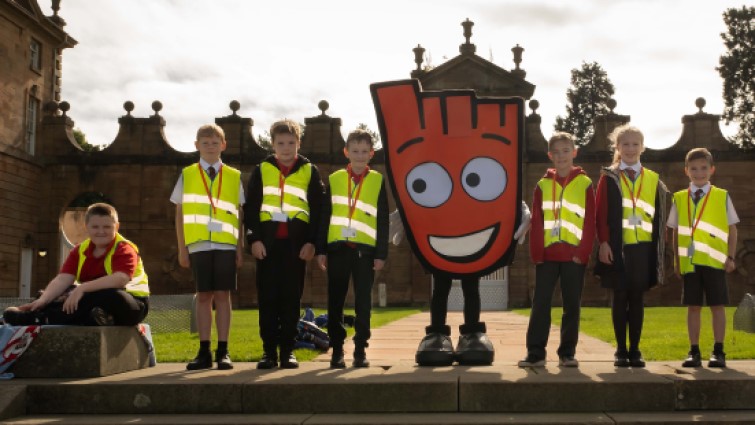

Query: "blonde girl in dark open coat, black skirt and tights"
<box><xmin>595</xmin><ymin>125</ymin><xmax>668</xmax><ymax>367</ymax></box>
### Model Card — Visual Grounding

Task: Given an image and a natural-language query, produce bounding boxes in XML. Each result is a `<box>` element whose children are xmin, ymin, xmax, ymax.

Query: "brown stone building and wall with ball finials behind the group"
<box><xmin>0</xmin><ymin>7</ymin><xmax>755</xmax><ymax>307</ymax></box>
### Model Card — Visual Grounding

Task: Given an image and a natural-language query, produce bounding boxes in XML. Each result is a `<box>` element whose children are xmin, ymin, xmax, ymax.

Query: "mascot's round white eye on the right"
<box><xmin>461</xmin><ymin>157</ymin><xmax>508</xmax><ymax>202</ymax></box>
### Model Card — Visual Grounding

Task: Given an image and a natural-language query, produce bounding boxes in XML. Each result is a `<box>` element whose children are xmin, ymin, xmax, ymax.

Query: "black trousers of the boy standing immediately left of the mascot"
<box><xmin>328</xmin><ymin>246</ymin><xmax>375</xmax><ymax>349</ymax></box>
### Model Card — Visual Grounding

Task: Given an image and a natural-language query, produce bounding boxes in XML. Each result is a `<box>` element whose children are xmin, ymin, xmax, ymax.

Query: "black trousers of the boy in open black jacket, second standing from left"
<box><xmin>257</xmin><ymin>239</ymin><xmax>307</xmax><ymax>355</ymax></box>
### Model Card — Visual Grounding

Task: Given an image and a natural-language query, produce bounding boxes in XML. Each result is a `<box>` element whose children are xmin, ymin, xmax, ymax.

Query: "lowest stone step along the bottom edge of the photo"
<box><xmin>0</xmin><ymin>411</ymin><xmax>755</xmax><ymax>425</ymax></box>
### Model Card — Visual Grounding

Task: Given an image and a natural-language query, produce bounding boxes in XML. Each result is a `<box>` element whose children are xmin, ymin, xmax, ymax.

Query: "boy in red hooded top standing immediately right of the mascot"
<box><xmin>519</xmin><ymin>132</ymin><xmax>595</xmax><ymax>367</ymax></box>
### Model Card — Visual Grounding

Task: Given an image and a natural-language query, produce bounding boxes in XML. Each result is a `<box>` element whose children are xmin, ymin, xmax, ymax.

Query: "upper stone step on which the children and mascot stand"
<box><xmin>8</xmin><ymin>361</ymin><xmax>755</xmax><ymax>417</ymax></box>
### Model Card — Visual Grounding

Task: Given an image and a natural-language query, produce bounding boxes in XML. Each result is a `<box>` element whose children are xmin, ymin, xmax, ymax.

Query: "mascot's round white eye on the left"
<box><xmin>406</xmin><ymin>162</ymin><xmax>453</xmax><ymax>208</ymax></box>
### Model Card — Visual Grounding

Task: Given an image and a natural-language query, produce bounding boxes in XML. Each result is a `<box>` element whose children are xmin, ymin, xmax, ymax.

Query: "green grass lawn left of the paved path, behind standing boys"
<box><xmin>150</xmin><ymin>308</ymin><xmax>421</xmax><ymax>363</ymax></box>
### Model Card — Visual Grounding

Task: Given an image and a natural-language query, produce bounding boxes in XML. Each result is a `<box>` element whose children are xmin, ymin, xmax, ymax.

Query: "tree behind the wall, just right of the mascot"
<box><xmin>554</xmin><ymin>62</ymin><xmax>614</xmax><ymax>146</ymax></box>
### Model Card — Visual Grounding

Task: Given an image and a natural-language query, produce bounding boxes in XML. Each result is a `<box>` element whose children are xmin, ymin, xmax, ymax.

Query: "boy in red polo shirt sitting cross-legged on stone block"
<box><xmin>3</xmin><ymin>203</ymin><xmax>149</xmax><ymax>326</ymax></box>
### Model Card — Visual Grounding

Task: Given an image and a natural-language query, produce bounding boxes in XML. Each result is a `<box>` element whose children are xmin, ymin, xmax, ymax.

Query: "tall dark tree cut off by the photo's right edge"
<box><xmin>716</xmin><ymin>6</ymin><xmax>755</xmax><ymax>148</ymax></box>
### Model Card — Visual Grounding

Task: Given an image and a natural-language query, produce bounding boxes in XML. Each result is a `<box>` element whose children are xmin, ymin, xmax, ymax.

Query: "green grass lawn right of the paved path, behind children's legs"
<box><xmin>514</xmin><ymin>307</ymin><xmax>755</xmax><ymax>360</ymax></box>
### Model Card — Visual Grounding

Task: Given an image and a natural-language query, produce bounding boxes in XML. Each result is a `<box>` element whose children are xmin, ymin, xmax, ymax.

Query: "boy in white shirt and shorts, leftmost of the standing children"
<box><xmin>170</xmin><ymin>124</ymin><xmax>244</xmax><ymax>370</ymax></box>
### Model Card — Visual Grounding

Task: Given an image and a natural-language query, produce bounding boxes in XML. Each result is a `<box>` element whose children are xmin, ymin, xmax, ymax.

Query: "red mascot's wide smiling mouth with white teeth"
<box><xmin>427</xmin><ymin>223</ymin><xmax>500</xmax><ymax>263</ymax></box>
